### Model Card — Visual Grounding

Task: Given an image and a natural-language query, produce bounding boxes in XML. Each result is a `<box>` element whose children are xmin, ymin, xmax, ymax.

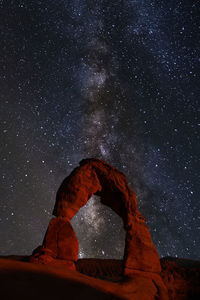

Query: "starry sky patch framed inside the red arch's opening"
<box><xmin>71</xmin><ymin>195</ymin><xmax>126</xmax><ymax>259</ymax></box>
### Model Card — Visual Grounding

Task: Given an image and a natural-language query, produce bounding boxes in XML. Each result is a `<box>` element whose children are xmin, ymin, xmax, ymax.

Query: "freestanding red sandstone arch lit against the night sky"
<box><xmin>30</xmin><ymin>159</ymin><xmax>161</xmax><ymax>275</ymax></box>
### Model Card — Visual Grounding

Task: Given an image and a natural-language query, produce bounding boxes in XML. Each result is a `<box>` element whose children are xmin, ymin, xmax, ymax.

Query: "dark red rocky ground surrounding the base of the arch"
<box><xmin>0</xmin><ymin>255</ymin><xmax>200</xmax><ymax>300</ymax></box>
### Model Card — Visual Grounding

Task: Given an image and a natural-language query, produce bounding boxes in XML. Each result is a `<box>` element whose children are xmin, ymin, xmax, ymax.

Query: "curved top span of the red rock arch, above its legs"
<box><xmin>53</xmin><ymin>158</ymin><xmax>140</xmax><ymax>229</ymax></box>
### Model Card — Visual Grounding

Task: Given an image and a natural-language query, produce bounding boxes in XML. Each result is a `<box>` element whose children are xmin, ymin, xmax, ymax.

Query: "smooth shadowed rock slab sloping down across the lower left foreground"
<box><xmin>0</xmin><ymin>259</ymin><xmax>122</xmax><ymax>300</ymax></box>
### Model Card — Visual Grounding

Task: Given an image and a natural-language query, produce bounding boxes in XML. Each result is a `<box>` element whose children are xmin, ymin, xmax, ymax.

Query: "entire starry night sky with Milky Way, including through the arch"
<box><xmin>0</xmin><ymin>0</ymin><xmax>200</xmax><ymax>259</ymax></box>
